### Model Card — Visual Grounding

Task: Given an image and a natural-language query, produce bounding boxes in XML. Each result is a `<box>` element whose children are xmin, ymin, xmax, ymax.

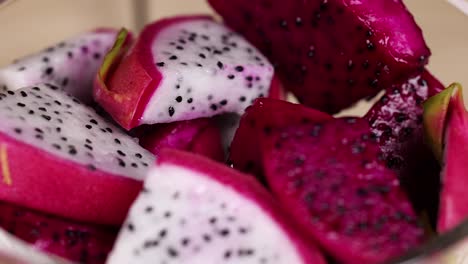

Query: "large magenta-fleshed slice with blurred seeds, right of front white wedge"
<box><xmin>263</xmin><ymin>118</ymin><xmax>424</xmax><ymax>263</ymax></box>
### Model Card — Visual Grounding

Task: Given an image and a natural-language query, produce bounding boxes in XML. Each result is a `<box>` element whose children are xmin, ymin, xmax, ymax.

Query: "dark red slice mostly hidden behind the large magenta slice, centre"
<box><xmin>229</xmin><ymin>98</ymin><xmax>333</xmax><ymax>177</ymax></box>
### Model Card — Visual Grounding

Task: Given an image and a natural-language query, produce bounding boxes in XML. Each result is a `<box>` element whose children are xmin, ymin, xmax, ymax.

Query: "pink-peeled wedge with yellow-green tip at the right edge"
<box><xmin>424</xmin><ymin>83</ymin><xmax>468</xmax><ymax>232</ymax></box>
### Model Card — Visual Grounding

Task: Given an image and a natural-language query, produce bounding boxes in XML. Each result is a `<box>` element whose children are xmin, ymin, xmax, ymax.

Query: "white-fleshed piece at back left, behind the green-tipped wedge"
<box><xmin>0</xmin><ymin>29</ymin><xmax>117</xmax><ymax>103</ymax></box>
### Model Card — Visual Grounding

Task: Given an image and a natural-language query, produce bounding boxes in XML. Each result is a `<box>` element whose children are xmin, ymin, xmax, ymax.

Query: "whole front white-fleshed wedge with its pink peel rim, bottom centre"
<box><xmin>107</xmin><ymin>150</ymin><xmax>325</xmax><ymax>264</ymax></box>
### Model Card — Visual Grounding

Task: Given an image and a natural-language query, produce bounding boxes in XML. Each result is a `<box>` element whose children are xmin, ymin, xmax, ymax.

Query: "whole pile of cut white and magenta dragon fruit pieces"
<box><xmin>0</xmin><ymin>0</ymin><xmax>468</xmax><ymax>264</ymax></box>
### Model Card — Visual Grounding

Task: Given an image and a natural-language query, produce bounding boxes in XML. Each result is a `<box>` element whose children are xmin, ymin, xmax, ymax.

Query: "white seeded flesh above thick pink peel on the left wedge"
<box><xmin>0</xmin><ymin>85</ymin><xmax>153</xmax><ymax>180</ymax></box>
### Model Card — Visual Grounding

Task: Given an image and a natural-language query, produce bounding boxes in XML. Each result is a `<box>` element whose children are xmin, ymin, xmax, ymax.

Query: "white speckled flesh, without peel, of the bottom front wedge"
<box><xmin>108</xmin><ymin>164</ymin><xmax>308</xmax><ymax>264</ymax></box>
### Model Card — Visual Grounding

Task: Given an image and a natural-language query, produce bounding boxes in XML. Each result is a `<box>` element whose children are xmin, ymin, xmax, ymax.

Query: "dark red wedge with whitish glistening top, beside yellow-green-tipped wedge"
<box><xmin>365</xmin><ymin>71</ymin><xmax>444</xmax><ymax>225</ymax></box>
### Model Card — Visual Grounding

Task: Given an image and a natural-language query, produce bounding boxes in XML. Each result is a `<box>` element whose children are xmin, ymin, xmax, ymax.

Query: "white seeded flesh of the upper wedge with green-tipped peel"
<box><xmin>138</xmin><ymin>19</ymin><xmax>273</xmax><ymax>123</ymax></box>
